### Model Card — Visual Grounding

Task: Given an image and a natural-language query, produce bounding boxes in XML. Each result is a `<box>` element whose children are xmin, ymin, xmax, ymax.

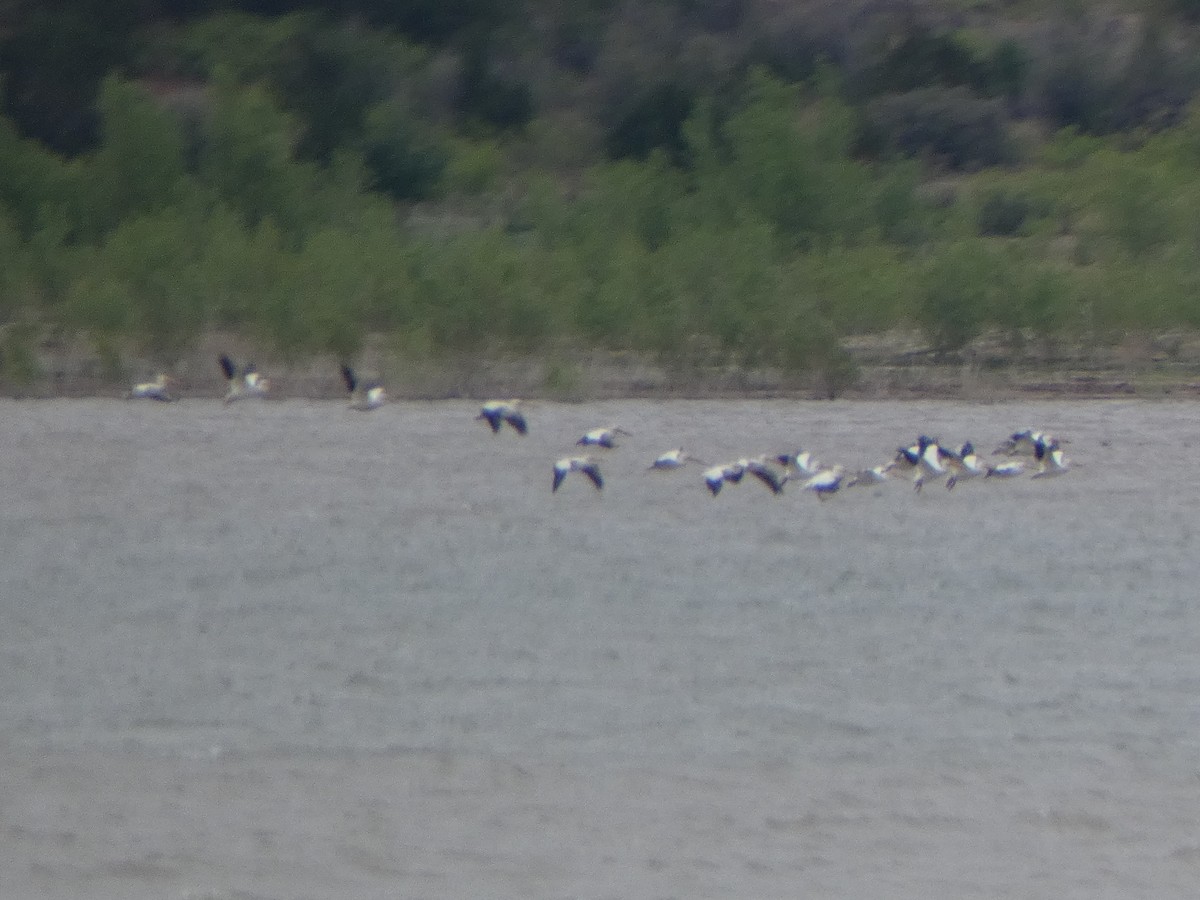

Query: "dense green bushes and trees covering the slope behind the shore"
<box><xmin>0</xmin><ymin>0</ymin><xmax>1200</xmax><ymax>386</ymax></box>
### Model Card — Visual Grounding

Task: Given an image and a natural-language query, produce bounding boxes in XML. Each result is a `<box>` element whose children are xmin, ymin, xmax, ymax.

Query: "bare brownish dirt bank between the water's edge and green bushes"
<box><xmin>7</xmin><ymin>332</ymin><xmax>1200</xmax><ymax>401</ymax></box>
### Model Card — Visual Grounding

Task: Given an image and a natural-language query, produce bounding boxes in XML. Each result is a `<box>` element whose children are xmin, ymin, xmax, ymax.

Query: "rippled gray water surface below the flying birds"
<box><xmin>0</xmin><ymin>400</ymin><xmax>1200</xmax><ymax>900</ymax></box>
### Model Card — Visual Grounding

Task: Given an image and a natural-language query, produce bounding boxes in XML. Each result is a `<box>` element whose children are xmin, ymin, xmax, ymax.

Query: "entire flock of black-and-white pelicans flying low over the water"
<box><xmin>126</xmin><ymin>354</ymin><xmax>1070</xmax><ymax>500</ymax></box>
